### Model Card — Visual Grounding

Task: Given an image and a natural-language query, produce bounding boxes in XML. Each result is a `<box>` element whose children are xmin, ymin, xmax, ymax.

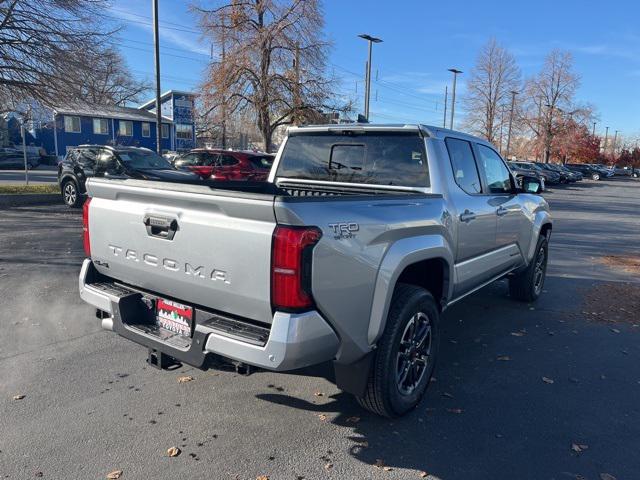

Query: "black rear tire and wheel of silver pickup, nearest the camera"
<box><xmin>357</xmin><ymin>284</ymin><xmax>440</xmax><ymax>418</ymax></box>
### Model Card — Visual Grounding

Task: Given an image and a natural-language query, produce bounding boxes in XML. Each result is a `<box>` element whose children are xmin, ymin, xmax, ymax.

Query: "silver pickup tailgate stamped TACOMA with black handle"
<box><xmin>87</xmin><ymin>179</ymin><xmax>275</xmax><ymax>323</ymax></box>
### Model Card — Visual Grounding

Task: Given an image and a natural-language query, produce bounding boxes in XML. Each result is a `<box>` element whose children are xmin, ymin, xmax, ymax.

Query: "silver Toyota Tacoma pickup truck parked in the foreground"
<box><xmin>79</xmin><ymin>124</ymin><xmax>552</xmax><ymax>416</ymax></box>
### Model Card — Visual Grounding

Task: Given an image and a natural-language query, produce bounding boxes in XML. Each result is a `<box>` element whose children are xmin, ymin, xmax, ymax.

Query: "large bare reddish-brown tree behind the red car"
<box><xmin>192</xmin><ymin>0</ymin><xmax>342</xmax><ymax>151</ymax></box>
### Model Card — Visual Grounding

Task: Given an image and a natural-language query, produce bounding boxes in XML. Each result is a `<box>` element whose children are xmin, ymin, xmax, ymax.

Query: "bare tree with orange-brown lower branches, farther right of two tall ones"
<box><xmin>522</xmin><ymin>50</ymin><xmax>580</xmax><ymax>162</ymax></box>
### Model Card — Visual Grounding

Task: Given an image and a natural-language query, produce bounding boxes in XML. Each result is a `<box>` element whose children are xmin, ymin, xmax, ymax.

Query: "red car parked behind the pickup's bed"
<box><xmin>174</xmin><ymin>148</ymin><xmax>274</xmax><ymax>181</ymax></box>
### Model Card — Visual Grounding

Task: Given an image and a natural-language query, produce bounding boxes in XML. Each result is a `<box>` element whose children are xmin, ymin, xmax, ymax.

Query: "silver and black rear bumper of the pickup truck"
<box><xmin>79</xmin><ymin>259</ymin><xmax>339</xmax><ymax>371</ymax></box>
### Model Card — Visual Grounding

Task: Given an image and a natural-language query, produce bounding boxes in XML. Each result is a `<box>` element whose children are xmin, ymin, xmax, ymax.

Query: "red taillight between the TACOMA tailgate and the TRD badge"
<box><xmin>271</xmin><ymin>226</ymin><xmax>322</xmax><ymax>311</ymax></box>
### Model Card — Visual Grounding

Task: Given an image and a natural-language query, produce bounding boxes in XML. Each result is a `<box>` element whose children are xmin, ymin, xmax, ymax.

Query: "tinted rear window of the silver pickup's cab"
<box><xmin>278</xmin><ymin>132</ymin><xmax>429</xmax><ymax>187</ymax></box>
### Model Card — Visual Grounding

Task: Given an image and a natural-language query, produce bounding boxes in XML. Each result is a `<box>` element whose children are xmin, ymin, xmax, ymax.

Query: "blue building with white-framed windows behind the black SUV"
<box><xmin>45</xmin><ymin>90</ymin><xmax>196</xmax><ymax>156</ymax></box>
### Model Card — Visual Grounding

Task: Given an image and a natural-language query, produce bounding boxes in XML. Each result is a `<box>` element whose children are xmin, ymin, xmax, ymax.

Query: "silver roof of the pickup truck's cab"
<box><xmin>287</xmin><ymin>123</ymin><xmax>491</xmax><ymax>145</ymax></box>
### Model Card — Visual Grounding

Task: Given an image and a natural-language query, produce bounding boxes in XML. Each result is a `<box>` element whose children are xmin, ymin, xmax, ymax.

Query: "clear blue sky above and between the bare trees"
<box><xmin>109</xmin><ymin>0</ymin><xmax>640</xmax><ymax>136</ymax></box>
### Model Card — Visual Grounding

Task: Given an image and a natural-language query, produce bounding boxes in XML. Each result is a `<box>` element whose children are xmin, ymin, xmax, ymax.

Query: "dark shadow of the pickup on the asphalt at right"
<box><xmin>257</xmin><ymin>277</ymin><xmax>640</xmax><ymax>480</ymax></box>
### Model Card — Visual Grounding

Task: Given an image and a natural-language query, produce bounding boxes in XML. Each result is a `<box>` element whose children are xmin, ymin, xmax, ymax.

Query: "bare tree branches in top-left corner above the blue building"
<box><xmin>0</xmin><ymin>0</ymin><xmax>112</xmax><ymax>110</ymax></box>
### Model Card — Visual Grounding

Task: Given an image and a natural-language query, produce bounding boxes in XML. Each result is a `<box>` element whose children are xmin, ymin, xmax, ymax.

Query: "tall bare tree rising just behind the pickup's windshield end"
<box><xmin>464</xmin><ymin>39</ymin><xmax>520</xmax><ymax>142</ymax></box>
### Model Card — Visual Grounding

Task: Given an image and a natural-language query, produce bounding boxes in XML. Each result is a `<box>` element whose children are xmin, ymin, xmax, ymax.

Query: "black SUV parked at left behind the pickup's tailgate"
<box><xmin>58</xmin><ymin>145</ymin><xmax>199</xmax><ymax>207</ymax></box>
